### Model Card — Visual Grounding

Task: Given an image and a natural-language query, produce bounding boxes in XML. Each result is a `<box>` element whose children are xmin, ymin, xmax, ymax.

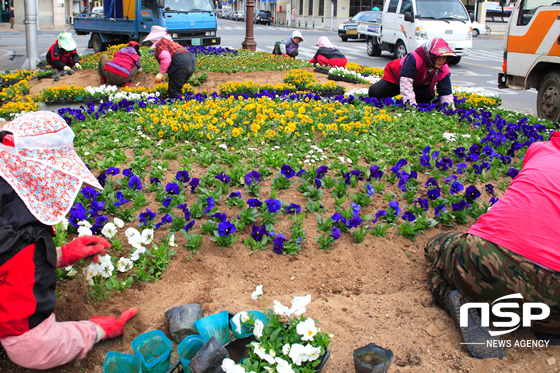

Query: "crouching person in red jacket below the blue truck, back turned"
<box><xmin>98</xmin><ymin>41</ymin><xmax>142</xmax><ymax>87</ymax></box>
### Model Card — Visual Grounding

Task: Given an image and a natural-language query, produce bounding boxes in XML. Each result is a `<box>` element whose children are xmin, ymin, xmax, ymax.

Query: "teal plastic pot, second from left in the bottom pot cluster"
<box><xmin>131</xmin><ymin>330</ymin><xmax>173</xmax><ymax>373</ymax></box>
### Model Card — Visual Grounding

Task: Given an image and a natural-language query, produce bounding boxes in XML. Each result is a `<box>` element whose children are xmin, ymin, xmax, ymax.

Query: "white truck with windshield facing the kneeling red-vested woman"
<box><xmin>358</xmin><ymin>0</ymin><xmax>473</xmax><ymax>64</ymax></box>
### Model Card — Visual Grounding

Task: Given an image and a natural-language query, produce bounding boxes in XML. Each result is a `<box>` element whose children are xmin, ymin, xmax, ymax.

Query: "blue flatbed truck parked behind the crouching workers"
<box><xmin>74</xmin><ymin>0</ymin><xmax>222</xmax><ymax>53</ymax></box>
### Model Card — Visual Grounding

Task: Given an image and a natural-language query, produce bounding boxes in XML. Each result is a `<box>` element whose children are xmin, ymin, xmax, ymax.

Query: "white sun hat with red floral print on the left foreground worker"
<box><xmin>0</xmin><ymin>111</ymin><xmax>103</xmax><ymax>225</ymax></box>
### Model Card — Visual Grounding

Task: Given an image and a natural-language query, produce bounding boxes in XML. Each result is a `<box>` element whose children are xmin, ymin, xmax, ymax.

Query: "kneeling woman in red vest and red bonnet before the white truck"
<box><xmin>369</xmin><ymin>38</ymin><xmax>457</xmax><ymax>107</ymax></box>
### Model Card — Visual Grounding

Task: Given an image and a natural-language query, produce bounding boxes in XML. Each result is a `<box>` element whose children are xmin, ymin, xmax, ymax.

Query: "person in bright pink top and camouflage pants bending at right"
<box><xmin>425</xmin><ymin>132</ymin><xmax>560</xmax><ymax>359</ymax></box>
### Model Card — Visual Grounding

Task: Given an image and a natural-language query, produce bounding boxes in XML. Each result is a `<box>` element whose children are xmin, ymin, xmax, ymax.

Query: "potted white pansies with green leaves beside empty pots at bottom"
<box><xmin>222</xmin><ymin>285</ymin><xmax>333</xmax><ymax>373</ymax></box>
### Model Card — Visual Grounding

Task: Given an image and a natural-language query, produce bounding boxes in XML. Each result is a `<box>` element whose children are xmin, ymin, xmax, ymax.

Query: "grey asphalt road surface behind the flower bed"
<box><xmin>0</xmin><ymin>19</ymin><xmax>537</xmax><ymax>115</ymax></box>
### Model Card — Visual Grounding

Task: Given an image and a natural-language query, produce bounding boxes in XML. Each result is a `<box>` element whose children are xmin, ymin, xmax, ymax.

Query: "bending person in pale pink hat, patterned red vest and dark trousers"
<box><xmin>144</xmin><ymin>26</ymin><xmax>196</xmax><ymax>98</ymax></box>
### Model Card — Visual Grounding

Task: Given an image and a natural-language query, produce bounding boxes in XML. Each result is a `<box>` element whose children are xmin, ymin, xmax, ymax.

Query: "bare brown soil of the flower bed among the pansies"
<box><xmin>0</xmin><ymin>71</ymin><xmax>560</xmax><ymax>373</ymax></box>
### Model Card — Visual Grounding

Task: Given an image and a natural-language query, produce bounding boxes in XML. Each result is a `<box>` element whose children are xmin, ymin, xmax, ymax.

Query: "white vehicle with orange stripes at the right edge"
<box><xmin>498</xmin><ymin>0</ymin><xmax>560</xmax><ymax>122</ymax></box>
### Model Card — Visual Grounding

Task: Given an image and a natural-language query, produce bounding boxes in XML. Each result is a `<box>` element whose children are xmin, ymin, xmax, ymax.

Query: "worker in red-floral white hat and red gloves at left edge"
<box><xmin>0</xmin><ymin>111</ymin><xmax>137</xmax><ymax>369</ymax></box>
